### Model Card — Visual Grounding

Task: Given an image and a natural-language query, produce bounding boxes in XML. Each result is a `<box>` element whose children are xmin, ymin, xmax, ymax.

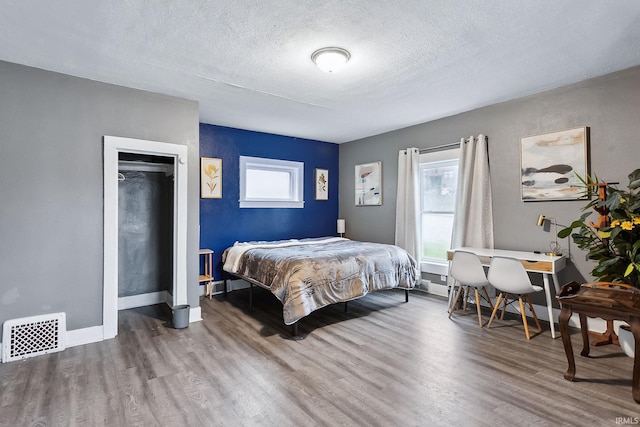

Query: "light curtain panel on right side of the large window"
<box><xmin>451</xmin><ymin>134</ymin><xmax>493</xmax><ymax>249</ymax></box>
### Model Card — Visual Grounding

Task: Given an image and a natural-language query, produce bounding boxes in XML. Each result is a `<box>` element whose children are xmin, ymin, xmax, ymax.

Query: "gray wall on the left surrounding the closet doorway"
<box><xmin>0</xmin><ymin>62</ymin><xmax>199</xmax><ymax>330</ymax></box>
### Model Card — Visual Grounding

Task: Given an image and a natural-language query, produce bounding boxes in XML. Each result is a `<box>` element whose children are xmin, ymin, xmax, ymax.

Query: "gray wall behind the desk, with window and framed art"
<box><xmin>340</xmin><ymin>67</ymin><xmax>640</xmax><ymax>294</ymax></box>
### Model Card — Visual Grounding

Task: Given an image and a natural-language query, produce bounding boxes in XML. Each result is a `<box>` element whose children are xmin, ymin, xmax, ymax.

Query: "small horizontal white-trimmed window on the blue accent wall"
<box><xmin>240</xmin><ymin>156</ymin><xmax>304</xmax><ymax>208</ymax></box>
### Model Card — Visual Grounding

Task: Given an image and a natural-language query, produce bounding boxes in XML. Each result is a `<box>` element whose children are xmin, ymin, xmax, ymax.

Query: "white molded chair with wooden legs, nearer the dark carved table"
<box><xmin>487</xmin><ymin>257</ymin><xmax>542</xmax><ymax>339</ymax></box>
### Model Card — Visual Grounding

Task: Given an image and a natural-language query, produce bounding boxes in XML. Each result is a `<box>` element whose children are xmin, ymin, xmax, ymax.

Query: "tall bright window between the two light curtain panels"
<box><xmin>420</xmin><ymin>149</ymin><xmax>460</xmax><ymax>274</ymax></box>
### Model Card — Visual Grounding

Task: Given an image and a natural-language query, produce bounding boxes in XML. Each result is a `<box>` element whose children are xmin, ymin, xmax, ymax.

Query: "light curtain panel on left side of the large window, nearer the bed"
<box><xmin>395</xmin><ymin>148</ymin><xmax>421</xmax><ymax>260</ymax></box>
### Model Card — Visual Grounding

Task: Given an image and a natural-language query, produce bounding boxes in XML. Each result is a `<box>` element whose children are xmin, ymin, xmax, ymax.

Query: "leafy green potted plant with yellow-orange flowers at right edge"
<box><xmin>558</xmin><ymin>169</ymin><xmax>640</xmax><ymax>357</ymax></box>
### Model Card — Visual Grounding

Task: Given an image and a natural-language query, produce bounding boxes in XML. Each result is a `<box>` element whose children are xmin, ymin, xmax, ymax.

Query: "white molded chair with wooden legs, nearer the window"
<box><xmin>449</xmin><ymin>251</ymin><xmax>493</xmax><ymax>327</ymax></box>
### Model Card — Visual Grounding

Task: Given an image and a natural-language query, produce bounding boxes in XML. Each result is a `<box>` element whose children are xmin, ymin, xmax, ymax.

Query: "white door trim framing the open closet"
<box><xmin>102</xmin><ymin>135</ymin><xmax>187</xmax><ymax>339</ymax></box>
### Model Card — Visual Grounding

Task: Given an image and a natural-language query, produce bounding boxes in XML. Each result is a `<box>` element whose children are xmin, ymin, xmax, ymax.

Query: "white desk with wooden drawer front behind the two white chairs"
<box><xmin>447</xmin><ymin>247</ymin><xmax>567</xmax><ymax>338</ymax></box>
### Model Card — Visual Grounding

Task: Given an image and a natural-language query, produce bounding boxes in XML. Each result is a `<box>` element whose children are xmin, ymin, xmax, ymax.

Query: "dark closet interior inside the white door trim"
<box><xmin>118</xmin><ymin>153</ymin><xmax>174</xmax><ymax>311</ymax></box>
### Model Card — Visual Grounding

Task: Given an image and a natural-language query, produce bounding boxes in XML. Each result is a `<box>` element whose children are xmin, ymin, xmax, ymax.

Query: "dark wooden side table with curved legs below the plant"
<box><xmin>557</xmin><ymin>282</ymin><xmax>640</xmax><ymax>403</ymax></box>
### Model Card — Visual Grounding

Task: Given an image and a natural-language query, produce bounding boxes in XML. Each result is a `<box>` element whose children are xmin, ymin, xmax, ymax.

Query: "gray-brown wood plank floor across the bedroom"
<box><xmin>0</xmin><ymin>289</ymin><xmax>640</xmax><ymax>427</ymax></box>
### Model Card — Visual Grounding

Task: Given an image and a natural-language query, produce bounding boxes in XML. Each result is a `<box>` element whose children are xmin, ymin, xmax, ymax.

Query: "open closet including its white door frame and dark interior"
<box><xmin>103</xmin><ymin>136</ymin><xmax>187</xmax><ymax>339</ymax></box>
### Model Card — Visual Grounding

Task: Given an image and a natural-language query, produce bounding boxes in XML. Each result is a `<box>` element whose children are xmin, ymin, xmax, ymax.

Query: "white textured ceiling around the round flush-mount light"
<box><xmin>0</xmin><ymin>0</ymin><xmax>640</xmax><ymax>143</ymax></box>
